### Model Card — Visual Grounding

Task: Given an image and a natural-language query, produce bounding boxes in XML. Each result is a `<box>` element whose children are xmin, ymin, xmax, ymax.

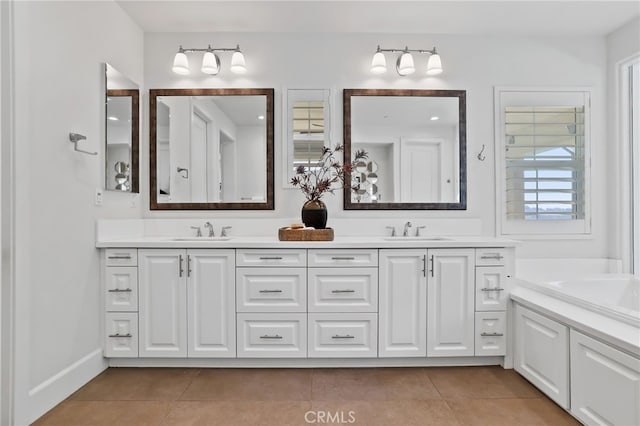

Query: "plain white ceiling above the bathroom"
<box><xmin>116</xmin><ymin>0</ymin><xmax>640</xmax><ymax>36</ymax></box>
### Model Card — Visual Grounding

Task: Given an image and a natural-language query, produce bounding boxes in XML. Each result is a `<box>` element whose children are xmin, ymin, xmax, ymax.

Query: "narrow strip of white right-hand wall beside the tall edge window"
<box><xmin>606</xmin><ymin>18</ymin><xmax>640</xmax><ymax>271</ymax></box>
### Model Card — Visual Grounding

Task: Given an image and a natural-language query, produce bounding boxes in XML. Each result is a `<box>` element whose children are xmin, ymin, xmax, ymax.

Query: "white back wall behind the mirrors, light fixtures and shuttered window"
<box><xmin>141</xmin><ymin>33</ymin><xmax>610</xmax><ymax>257</ymax></box>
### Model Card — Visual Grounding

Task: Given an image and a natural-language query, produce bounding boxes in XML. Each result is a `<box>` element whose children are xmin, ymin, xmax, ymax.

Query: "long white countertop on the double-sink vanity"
<box><xmin>96</xmin><ymin>236</ymin><xmax>518</xmax><ymax>248</ymax></box>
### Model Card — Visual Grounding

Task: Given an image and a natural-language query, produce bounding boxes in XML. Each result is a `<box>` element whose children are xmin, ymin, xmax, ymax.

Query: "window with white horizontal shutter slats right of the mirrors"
<box><xmin>504</xmin><ymin>105</ymin><xmax>585</xmax><ymax>221</ymax></box>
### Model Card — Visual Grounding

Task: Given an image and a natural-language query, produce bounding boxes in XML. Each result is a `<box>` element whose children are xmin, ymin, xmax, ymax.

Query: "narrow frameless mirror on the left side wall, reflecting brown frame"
<box><xmin>105</xmin><ymin>63</ymin><xmax>140</xmax><ymax>193</ymax></box>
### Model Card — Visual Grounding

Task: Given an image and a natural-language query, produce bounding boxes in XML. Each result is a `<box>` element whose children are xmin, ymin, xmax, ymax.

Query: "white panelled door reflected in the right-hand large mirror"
<box><xmin>400</xmin><ymin>139</ymin><xmax>442</xmax><ymax>203</ymax></box>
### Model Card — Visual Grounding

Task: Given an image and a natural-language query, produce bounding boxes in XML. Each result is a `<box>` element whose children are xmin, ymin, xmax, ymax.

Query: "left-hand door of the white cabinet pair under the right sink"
<box><xmin>378</xmin><ymin>249</ymin><xmax>427</xmax><ymax>357</ymax></box>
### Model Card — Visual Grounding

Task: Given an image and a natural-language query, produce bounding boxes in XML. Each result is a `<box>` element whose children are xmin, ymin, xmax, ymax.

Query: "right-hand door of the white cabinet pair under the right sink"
<box><xmin>427</xmin><ymin>249</ymin><xmax>475</xmax><ymax>357</ymax></box>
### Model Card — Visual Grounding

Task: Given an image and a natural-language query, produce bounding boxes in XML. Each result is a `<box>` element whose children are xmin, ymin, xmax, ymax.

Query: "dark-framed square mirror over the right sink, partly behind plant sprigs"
<box><xmin>343</xmin><ymin>89</ymin><xmax>467</xmax><ymax>210</ymax></box>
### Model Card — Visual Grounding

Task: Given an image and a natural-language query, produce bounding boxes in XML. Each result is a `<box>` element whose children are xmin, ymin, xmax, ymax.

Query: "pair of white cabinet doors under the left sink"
<box><xmin>138</xmin><ymin>249</ymin><xmax>235</xmax><ymax>357</ymax></box>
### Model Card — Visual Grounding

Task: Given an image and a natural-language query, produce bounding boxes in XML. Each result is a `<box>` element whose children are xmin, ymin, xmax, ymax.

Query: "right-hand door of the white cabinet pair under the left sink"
<box><xmin>187</xmin><ymin>249</ymin><xmax>236</xmax><ymax>358</ymax></box>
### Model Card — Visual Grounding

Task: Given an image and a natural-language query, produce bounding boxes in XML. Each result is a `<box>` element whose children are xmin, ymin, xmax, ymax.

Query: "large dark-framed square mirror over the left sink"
<box><xmin>149</xmin><ymin>89</ymin><xmax>274</xmax><ymax>210</ymax></box>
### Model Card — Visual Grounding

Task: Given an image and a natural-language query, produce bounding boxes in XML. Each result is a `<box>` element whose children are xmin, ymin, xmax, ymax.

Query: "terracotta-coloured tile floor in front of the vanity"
<box><xmin>35</xmin><ymin>367</ymin><xmax>579</xmax><ymax>426</ymax></box>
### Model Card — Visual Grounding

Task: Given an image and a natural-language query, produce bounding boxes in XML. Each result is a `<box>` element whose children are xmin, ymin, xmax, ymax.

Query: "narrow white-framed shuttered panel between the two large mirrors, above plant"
<box><xmin>283</xmin><ymin>89</ymin><xmax>331</xmax><ymax>188</ymax></box>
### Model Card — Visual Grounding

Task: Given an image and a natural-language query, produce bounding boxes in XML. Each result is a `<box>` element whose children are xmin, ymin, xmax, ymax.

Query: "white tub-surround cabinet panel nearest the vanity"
<box><xmin>514</xmin><ymin>305</ymin><xmax>569</xmax><ymax>409</ymax></box>
